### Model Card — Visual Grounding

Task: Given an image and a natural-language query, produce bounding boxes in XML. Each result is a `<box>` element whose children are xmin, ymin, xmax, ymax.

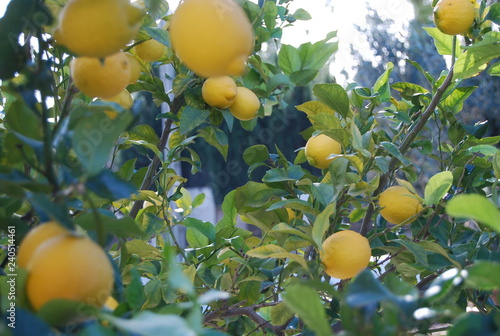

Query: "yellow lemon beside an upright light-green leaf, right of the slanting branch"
<box><xmin>378</xmin><ymin>186</ymin><xmax>423</xmax><ymax>224</ymax></box>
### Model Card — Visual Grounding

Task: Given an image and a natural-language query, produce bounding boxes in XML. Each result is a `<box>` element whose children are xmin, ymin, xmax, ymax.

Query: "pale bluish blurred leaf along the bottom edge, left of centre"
<box><xmin>101</xmin><ymin>311</ymin><xmax>197</xmax><ymax>336</ymax></box>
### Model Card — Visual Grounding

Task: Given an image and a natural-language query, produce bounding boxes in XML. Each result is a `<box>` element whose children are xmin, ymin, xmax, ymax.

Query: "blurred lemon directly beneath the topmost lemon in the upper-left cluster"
<box><xmin>70</xmin><ymin>51</ymin><xmax>131</xmax><ymax>98</ymax></box>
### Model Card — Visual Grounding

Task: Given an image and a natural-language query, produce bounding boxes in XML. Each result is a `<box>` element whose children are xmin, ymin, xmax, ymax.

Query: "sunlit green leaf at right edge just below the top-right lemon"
<box><xmin>453</xmin><ymin>32</ymin><xmax>500</xmax><ymax>79</ymax></box>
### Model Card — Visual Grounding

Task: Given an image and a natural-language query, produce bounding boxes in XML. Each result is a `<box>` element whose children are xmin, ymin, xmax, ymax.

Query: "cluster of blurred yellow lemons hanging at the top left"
<box><xmin>54</xmin><ymin>0</ymin><xmax>165</xmax><ymax>113</ymax></box>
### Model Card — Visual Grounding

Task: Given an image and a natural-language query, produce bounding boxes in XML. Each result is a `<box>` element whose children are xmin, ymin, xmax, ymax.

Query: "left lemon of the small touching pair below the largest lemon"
<box><xmin>201</xmin><ymin>76</ymin><xmax>238</xmax><ymax>109</ymax></box>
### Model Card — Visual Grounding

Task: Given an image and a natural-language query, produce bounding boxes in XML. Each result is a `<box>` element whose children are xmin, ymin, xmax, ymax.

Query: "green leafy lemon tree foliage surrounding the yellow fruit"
<box><xmin>0</xmin><ymin>0</ymin><xmax>500</xmax><ymax>336</ymax></box>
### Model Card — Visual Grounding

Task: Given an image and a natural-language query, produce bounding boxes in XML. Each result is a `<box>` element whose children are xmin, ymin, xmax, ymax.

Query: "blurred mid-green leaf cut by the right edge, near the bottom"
<box><xmin>466</xmin><ymin>260</ymin><xmax>500</xmax><ymax>290</ymax></box>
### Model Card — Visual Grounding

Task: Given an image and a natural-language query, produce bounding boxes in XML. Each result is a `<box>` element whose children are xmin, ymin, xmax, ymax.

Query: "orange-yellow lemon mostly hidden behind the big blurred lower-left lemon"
<box><xmin>17</xmin><ymin>221</ymin><xmax>69</xmax><ymax>268</ymax></box>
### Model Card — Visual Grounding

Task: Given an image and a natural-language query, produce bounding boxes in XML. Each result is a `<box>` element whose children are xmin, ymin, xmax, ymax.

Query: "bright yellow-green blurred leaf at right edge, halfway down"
<box><xmin>446</xmin><ymin>194</ymin><xmax>500</xmax><ymax>232</ymax></box>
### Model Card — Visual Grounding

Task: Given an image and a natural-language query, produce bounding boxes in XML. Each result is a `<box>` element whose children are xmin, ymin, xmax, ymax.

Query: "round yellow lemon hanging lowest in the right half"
<box><xmin>321</xmin><ymin>230</ymin><xmax>371</xmax><ymax>279</ymax></box>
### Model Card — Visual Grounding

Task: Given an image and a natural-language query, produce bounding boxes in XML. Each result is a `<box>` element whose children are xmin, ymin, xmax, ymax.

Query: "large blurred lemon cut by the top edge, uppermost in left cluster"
<box><xmin>54</xmin><ymin>0</ymin><xmax>143</xmax><ymax>58</ymax></box>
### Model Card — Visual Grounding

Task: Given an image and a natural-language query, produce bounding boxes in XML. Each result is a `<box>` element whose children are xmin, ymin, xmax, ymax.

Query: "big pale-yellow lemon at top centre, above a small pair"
<box><xmin>169</xmin><ymin>0</ymin><xmax>254</xmax><ymax>77</ymax></box>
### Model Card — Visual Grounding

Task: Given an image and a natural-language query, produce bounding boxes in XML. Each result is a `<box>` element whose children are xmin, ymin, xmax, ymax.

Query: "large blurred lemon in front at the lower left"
<box><xmin>26</xmin><ymin>234</ymin><xmax>113</xmax><ymax>310</ymax></box>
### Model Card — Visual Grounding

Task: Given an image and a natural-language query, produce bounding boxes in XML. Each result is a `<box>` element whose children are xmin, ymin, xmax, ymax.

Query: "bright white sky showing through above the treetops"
<box><xmin>0</xmin><ymin>0</ymin><xmax>413</xmax><ymax>84</ymax></box>
